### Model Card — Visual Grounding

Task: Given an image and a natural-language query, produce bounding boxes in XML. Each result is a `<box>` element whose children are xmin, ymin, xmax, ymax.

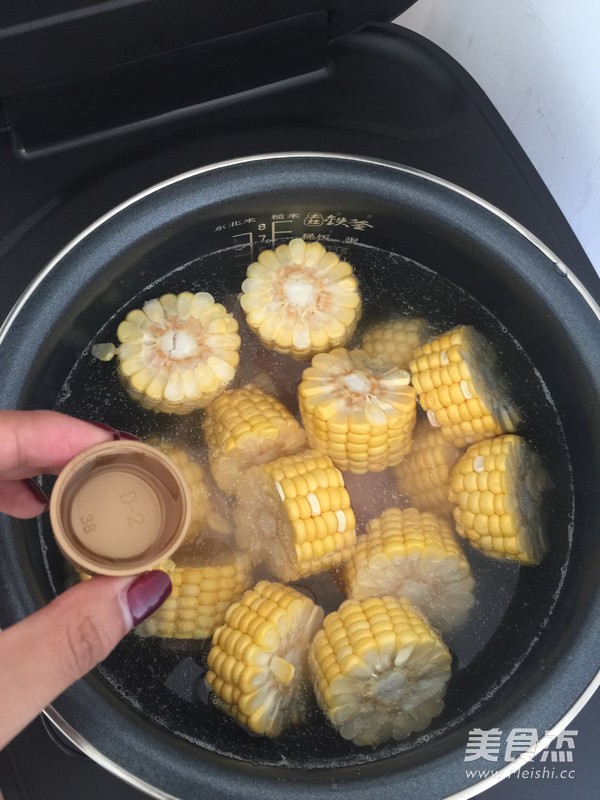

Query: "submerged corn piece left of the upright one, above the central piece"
<box><xmin>204</xmin><ymin>386</ymin><xmax>306</xmax><ymax>493</ymax></box>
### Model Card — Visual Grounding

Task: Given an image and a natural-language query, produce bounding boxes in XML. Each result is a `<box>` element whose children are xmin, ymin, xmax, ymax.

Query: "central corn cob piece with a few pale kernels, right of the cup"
<box><xmin>234</xmin><ymin>450</ymin><xmax>356</xmax><ymax>582</ymax></box>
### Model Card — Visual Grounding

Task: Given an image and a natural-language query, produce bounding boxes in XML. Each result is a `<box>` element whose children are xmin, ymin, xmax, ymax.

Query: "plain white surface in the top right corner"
<box><xmin>396</xmin><ymin>0</ymin><xmax>600</xmax><ymax>273</ymax></box>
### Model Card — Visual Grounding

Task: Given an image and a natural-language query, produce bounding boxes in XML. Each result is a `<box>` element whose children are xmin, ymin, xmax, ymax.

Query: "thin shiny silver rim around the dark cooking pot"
<box><xmin>0</xmin><ymin>151</ymin><xmax>600</xmax><ymax>800</ymax></box>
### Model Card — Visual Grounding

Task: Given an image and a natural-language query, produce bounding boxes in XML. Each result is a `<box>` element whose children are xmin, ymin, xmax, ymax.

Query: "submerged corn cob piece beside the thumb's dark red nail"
<box><xmin>136</xmin><ymin>539</ymin><xmax>252</xmax><ymax>639</ymax></box>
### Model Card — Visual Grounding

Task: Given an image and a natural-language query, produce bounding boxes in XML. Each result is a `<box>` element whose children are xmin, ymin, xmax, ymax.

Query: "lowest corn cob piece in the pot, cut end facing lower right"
<box><xmin>308</xmin><ymin>597</ymin><xmax>451</xmax><ymax>746</ymax></box>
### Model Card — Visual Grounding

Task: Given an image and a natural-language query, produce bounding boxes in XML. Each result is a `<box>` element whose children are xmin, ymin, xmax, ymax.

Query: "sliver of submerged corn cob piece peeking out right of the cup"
<box><xmin>147</xmin><ymin>437</ymin><xmax>230</xmax><ymax>544</ymax></box>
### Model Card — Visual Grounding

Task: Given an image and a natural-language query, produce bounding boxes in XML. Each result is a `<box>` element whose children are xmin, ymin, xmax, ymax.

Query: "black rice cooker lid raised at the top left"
<box><xmin>0</xmin><ymin>0</ymin><xmax>415</xmax><ymax>151</ymax></box>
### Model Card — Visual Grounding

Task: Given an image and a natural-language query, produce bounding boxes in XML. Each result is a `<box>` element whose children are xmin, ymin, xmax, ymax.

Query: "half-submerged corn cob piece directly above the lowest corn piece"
<box><xmin>344</xmin><ymin>508</ymin><xmax>474</xmax><ymax>631</ymax></box>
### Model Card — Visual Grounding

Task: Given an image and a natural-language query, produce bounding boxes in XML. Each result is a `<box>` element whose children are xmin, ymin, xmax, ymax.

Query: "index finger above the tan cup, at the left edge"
<box><xmin>0</xmin><ymin>411</ymin><xmax>119</xmax><ymax>480</ymax></box>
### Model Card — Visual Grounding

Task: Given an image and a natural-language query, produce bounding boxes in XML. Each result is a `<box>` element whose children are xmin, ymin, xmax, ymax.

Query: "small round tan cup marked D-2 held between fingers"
<box><xmin>50</xmin><ymin>441</ymin><xmax>191</xmax><ymax>575</ymax></box>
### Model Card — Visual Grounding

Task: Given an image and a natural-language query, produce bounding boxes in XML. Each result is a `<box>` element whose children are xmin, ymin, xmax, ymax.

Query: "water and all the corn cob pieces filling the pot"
<box><xmin>43</xmin><ymin>239</ymin><xmax>572</xmax><ymax>767</ymax></box>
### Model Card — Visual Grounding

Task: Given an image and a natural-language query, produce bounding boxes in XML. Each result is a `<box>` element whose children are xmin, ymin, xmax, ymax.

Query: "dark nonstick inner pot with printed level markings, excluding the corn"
<box><xmin>0</xmin><ymin>156</ymin><xmax>600</xmax><ymax>798</ymax></box>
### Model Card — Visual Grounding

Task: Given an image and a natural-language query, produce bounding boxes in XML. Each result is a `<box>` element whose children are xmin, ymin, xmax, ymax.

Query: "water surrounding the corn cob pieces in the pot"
<box><xmin>49</xmin><ymin>242</ymin><xmax>570</xmax><ymax>768</ymax></box>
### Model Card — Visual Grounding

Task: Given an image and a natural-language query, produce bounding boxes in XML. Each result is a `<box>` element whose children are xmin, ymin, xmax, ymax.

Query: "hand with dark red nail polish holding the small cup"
<box><xmin>0</xmin><ymin>411</ymin><xmax>171</xmax><ymax>749</ymax></box>
